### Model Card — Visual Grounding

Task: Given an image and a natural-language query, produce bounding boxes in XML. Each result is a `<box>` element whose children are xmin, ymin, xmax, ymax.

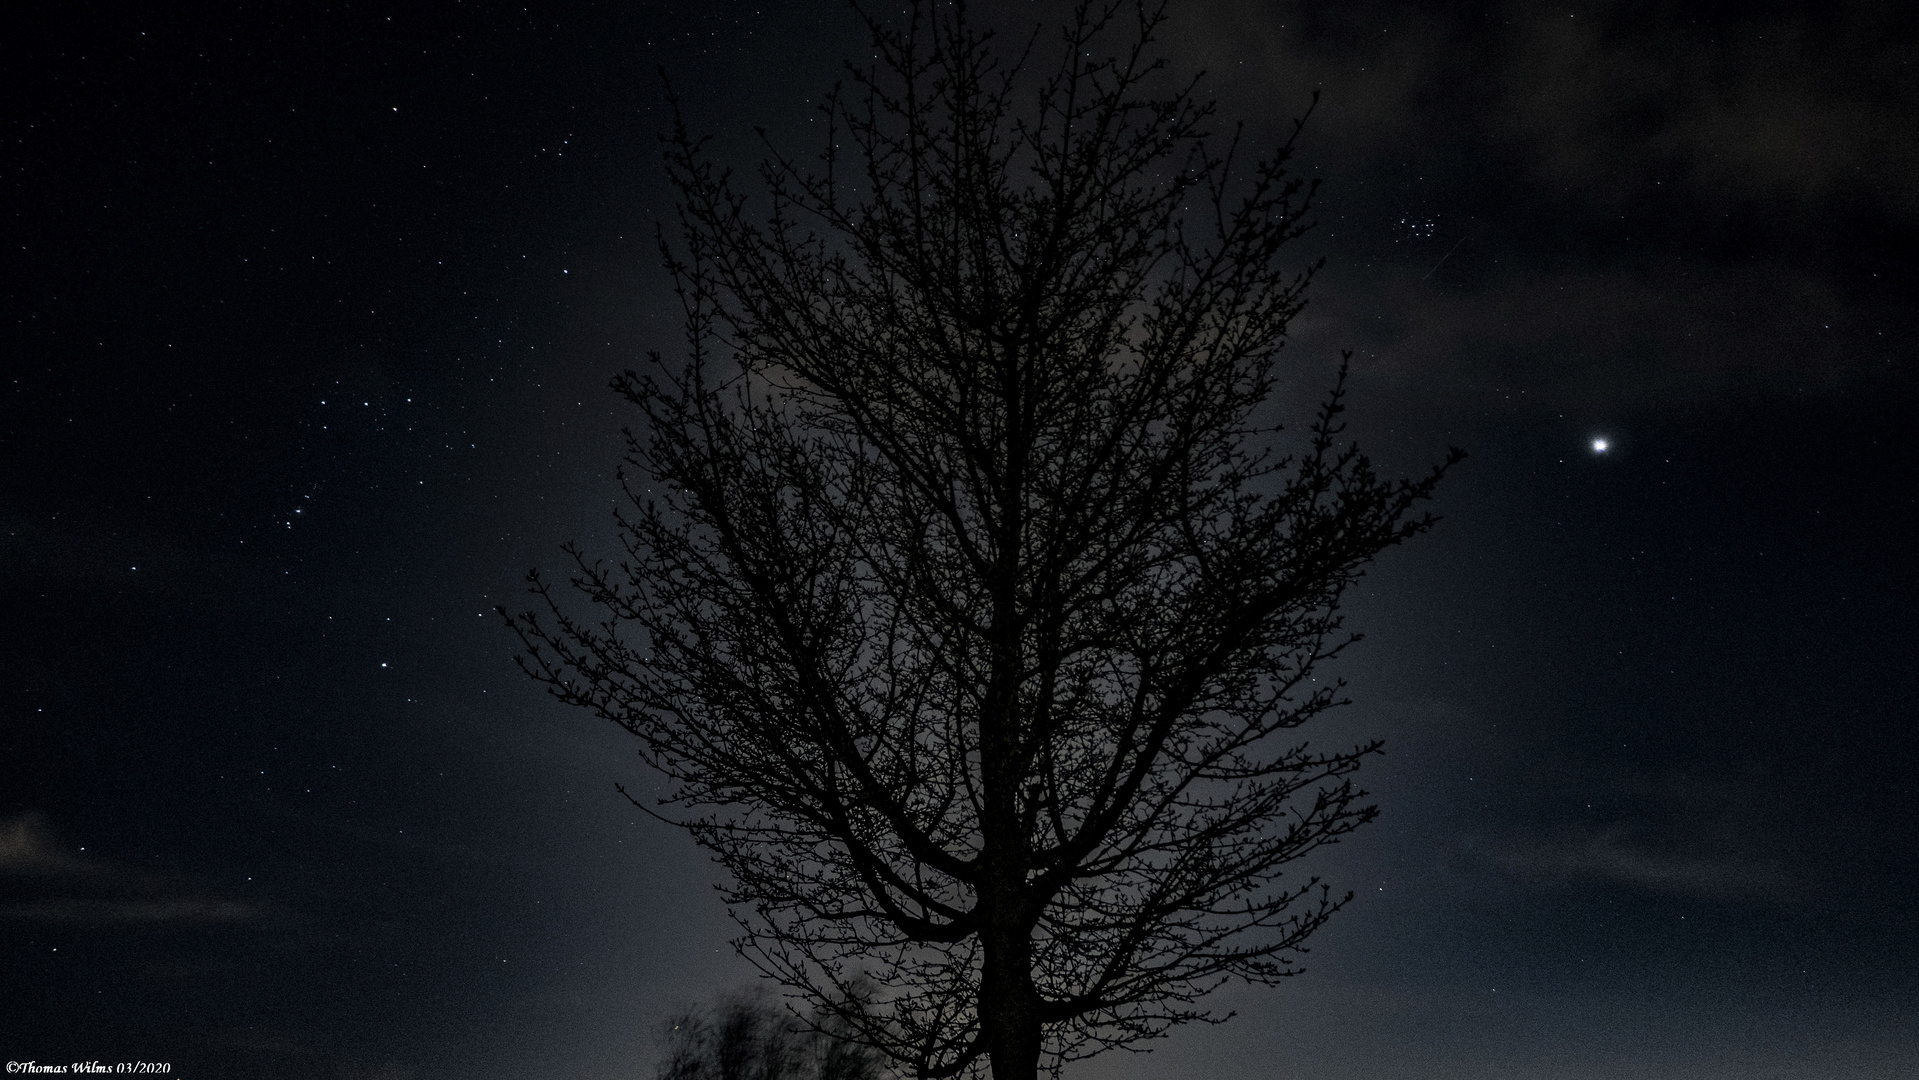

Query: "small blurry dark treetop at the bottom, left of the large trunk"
<box><xmin>658</xmin><ymin>992</ymin><xmax>883</xmax><ymax>1080</ymax></box>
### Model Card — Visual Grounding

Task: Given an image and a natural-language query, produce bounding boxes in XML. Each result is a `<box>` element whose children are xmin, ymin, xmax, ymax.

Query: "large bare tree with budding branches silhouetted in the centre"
<box><xmin>512</xmin><ymin>2</ymin><xmax>1458</xmax><ymax>1080</ymax></box>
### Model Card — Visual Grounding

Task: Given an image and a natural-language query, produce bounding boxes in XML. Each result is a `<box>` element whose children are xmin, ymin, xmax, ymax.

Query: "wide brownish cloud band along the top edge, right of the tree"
<box><xmin>1173</xmin><ymin>0</ymin><xmax>1919</xmax><ymax>221</ymax></box>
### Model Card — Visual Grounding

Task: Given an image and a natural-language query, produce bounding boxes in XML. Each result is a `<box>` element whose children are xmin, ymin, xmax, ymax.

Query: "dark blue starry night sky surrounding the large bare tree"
<box><xmin>0</xmin><ymin>0</ymin><xmax>1919</xmax><ymax>1080</ymax></box>
